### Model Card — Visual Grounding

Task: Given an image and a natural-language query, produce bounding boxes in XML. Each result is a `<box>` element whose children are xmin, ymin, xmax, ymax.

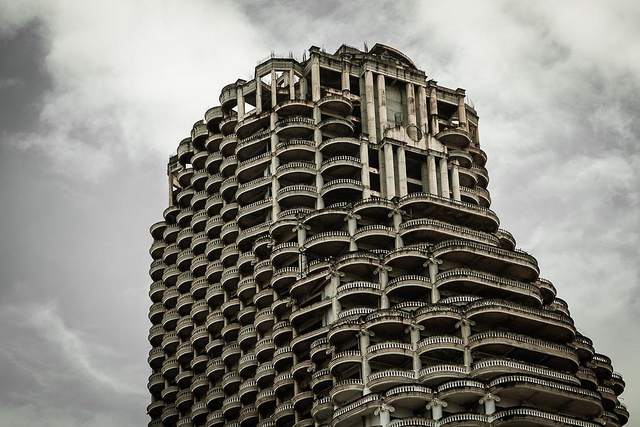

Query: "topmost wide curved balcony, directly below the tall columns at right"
<box><xmin>398</xmin><ymin>193</ymin><xmax>500</xmax><ymax>232</ymax></box>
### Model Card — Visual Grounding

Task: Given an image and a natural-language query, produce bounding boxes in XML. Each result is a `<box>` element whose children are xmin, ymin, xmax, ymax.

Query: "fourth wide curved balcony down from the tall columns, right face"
<box><xmin>436</xmin><ymin>268</ymin><xmax>542</xmax><ymax>306</ymax></box>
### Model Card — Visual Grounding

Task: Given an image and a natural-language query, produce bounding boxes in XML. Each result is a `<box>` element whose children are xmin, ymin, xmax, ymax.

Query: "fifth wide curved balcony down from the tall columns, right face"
<box><xmin>465</xmin><ymin>299</ymin><xmax>576</xmax><ymax>343</ymax></box>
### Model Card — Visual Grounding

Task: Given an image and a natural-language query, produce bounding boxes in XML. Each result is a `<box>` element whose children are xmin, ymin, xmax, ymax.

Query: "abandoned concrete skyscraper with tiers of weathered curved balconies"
<box><xmin>147</xmin><ymin>44</ymin><xmax>629</xmax><ymax>427</ymax></box>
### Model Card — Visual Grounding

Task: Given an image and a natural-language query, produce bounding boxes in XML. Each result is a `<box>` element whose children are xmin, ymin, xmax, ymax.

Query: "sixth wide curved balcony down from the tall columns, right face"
<box><xmin>469</xmin><ymin>331</ymin><xmax>580</xmax><ymax>372</ymax></box>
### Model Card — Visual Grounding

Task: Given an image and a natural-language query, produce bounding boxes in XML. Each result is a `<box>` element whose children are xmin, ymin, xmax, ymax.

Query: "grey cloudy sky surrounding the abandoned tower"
<box><xmin>0</xmin><ymin>0</ymin><xmax>640</xmax><ymax>427</ymax></box>
